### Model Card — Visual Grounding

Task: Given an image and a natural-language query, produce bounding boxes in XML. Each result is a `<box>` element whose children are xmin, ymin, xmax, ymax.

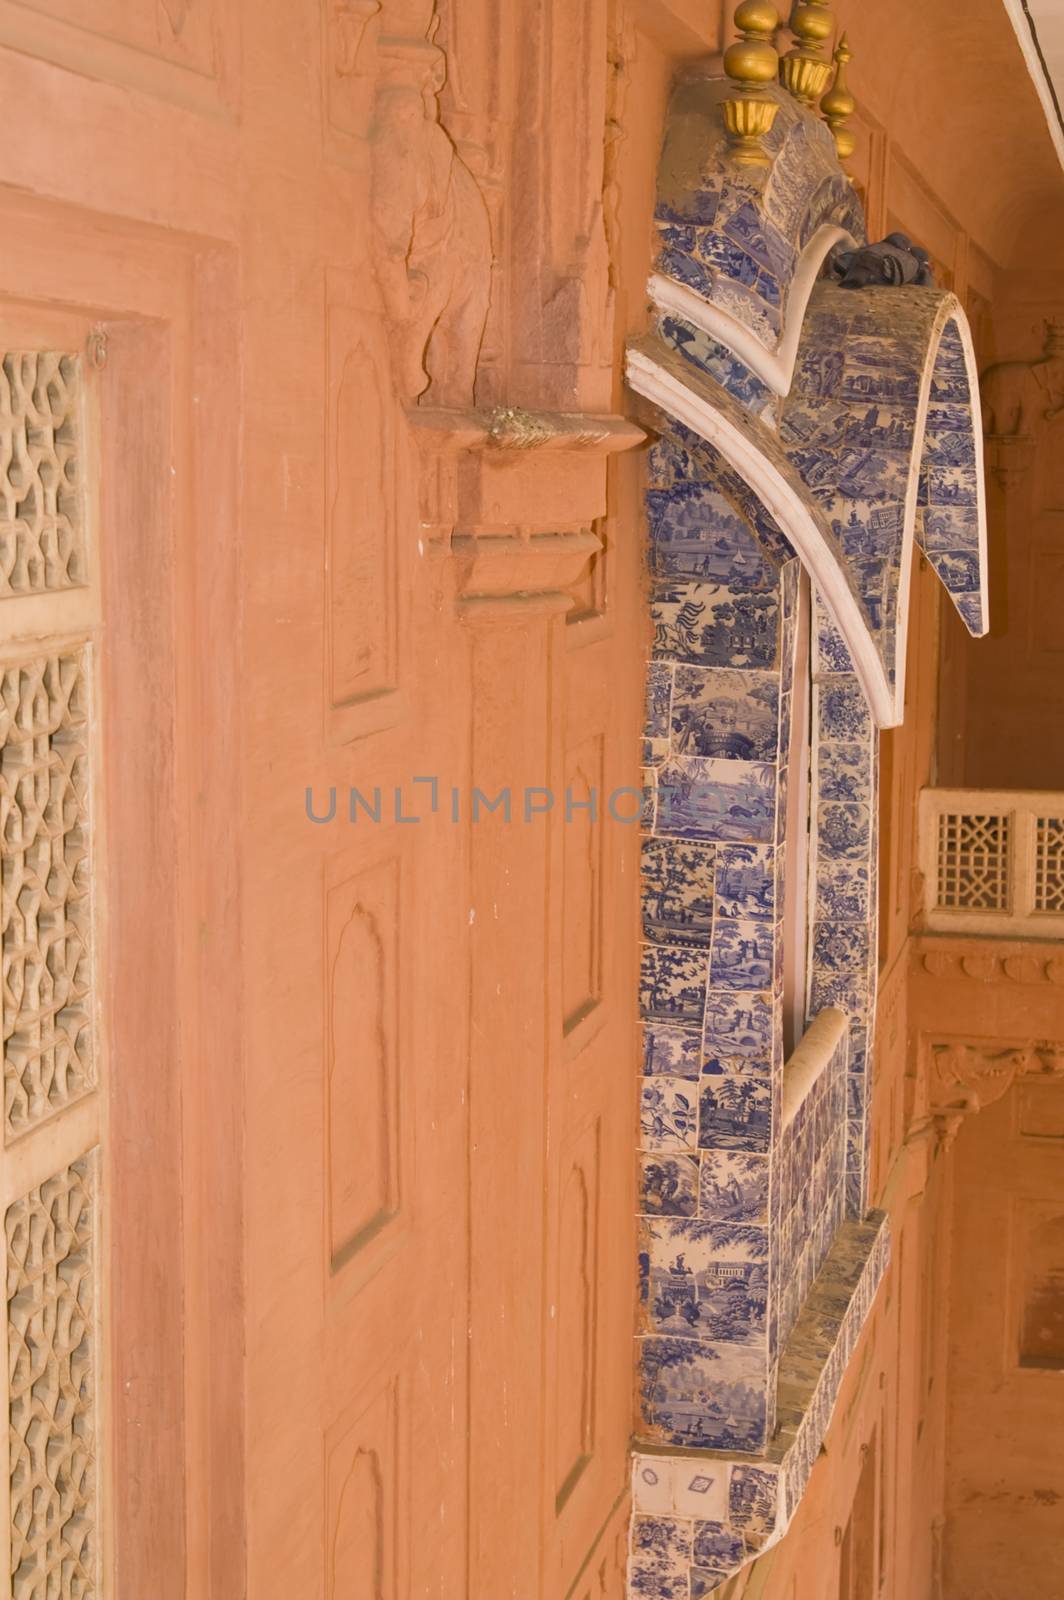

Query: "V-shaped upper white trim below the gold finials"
<box><xmin>646</xmin><ymin>224</ymin><xmax>856</xmax><ymax>395</ymax></box>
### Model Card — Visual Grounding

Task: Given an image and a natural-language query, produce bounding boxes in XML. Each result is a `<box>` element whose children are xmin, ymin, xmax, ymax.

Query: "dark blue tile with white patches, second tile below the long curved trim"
<box><xmin>650</xmin><ymin>579</ymin><xmax>779</xmax><ymax>667</ymax></box>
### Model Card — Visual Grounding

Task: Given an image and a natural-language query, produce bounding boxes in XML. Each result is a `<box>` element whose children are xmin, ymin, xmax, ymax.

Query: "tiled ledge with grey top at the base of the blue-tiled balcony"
<box><xmin>629</xmin><ymin>1211</ymin><xmax>890</xmax><ymax>1600</ymax></box>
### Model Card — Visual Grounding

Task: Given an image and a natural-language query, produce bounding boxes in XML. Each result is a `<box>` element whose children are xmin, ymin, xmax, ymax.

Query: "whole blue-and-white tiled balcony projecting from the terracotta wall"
<box><xmin>627</xmin><ymin>68</ymin><xmax>987</xmax><ymax>1600</ymax></box>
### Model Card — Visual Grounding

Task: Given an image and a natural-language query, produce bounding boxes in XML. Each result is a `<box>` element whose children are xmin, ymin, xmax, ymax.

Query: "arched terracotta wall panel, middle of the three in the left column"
<box><xmin>326</xmin><ymin>861</ymin><xmax>400</xmax><ymax>1270</ymax></box>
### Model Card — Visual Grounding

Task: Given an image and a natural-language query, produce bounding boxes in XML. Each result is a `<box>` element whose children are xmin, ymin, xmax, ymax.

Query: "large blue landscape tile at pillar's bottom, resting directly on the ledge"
<box><xmin>638</xmin><ymin>1338</ymin><xmax>766</xmax><ymax>1453</ymax></box>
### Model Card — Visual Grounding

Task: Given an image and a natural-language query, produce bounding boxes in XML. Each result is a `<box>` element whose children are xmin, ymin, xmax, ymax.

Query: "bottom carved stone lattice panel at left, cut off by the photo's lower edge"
<box><xmin>5</xmin><ymin>1150</ymin><xmax>99</xmax><ymax>1600</ymax></box>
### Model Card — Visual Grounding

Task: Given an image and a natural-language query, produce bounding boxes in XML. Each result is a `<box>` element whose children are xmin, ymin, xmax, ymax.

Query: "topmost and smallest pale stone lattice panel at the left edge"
<box><xmin>0</xmin><ymin>350</ymin><xmax>85</xmax><ymax>598</ymax></box>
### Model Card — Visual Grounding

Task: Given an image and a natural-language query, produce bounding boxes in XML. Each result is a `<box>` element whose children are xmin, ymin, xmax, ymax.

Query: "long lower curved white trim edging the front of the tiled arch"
<box><xmin>627</xmin><ymin>350</ymin><xmax>896</xmax><ymax>728</ymax></box>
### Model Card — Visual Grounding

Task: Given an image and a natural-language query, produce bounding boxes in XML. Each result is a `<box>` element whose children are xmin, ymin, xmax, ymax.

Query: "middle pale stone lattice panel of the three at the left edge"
<box><xmin>0</xmin><ymin>650</ymin><xmax>94</xmax><ymax>1141</ymax></box>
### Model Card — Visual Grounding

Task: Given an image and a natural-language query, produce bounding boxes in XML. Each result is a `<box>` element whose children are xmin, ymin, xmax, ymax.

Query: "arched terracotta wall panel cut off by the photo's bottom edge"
<box><xmin>325</xmin><ymin>1378</ymin><xmax>408</xmax><ymax>1600</ymax></box>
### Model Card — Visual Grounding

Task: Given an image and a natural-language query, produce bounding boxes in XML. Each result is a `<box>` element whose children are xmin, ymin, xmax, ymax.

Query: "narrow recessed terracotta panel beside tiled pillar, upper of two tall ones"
<box><xmin>562</xmin><ymin>734</ymin><xmax>606</xmax><ymax>1032</ymax></box>
